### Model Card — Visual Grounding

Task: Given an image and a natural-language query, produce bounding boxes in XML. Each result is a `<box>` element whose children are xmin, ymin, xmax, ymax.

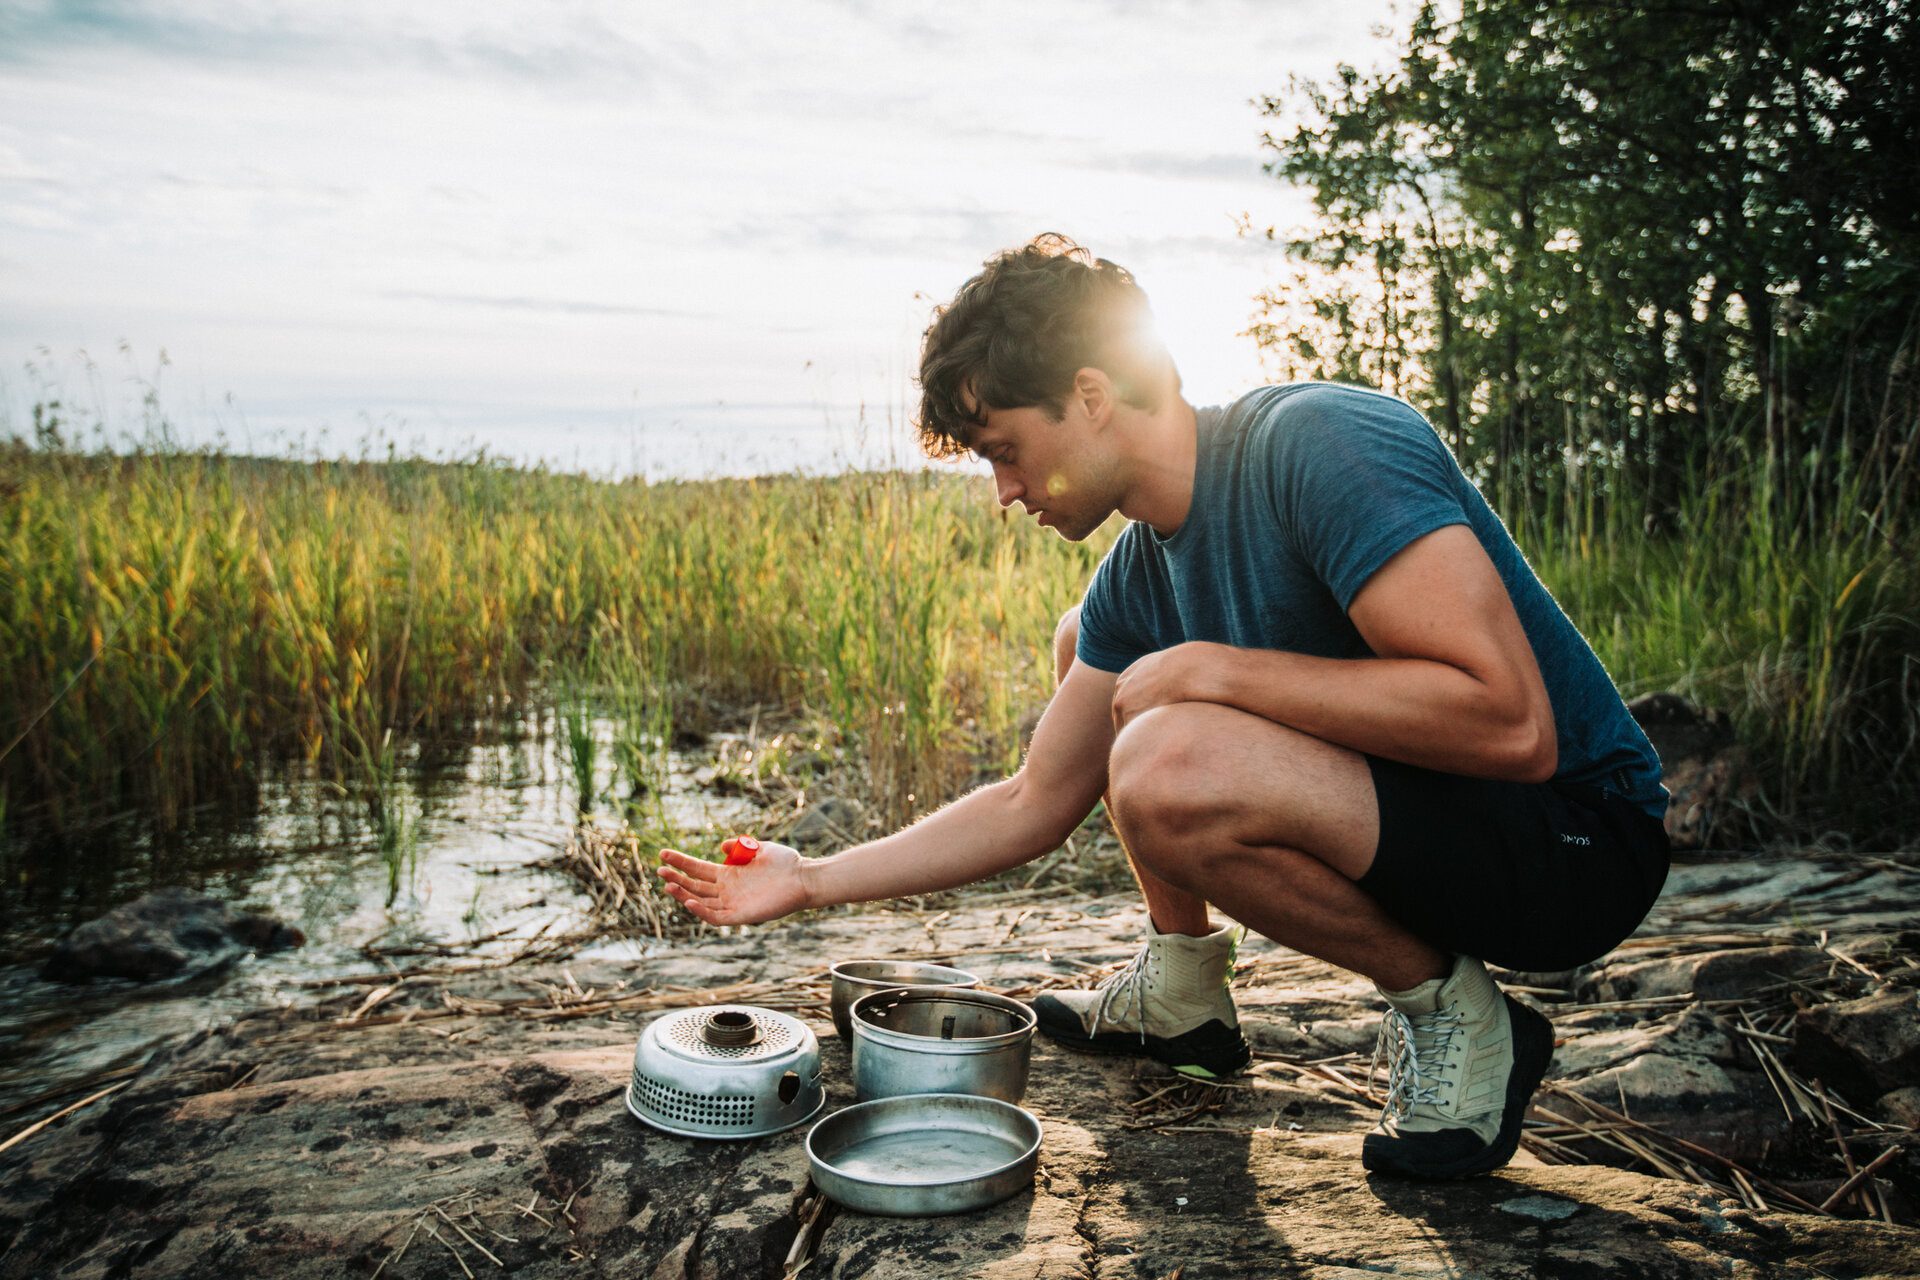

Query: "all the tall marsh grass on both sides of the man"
<box><xmin>0</xmin><ymin>420</ymin><xmax>1920</xmax><ymax>848</ymax></box>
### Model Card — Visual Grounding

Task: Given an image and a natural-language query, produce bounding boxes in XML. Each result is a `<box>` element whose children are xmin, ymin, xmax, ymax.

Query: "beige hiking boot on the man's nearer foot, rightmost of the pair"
<box><xmin>1359</xmin><ymin>956</ymin><xmax>1553</xmax><ymax>1178</ymax></box>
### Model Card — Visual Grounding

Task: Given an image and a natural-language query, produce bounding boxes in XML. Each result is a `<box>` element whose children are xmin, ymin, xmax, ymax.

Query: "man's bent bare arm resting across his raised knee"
<box><xmin>1114</xmin><ymin>524</ymin><xmax>1559</xmax><ymax>781</ymax></box>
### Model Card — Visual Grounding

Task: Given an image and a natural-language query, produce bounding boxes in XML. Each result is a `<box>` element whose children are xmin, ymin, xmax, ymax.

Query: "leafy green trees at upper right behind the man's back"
<box><xmin>1256</xmin><ymin>0</ymin><xmax>1920</xmax><ymax>528</ymax></box>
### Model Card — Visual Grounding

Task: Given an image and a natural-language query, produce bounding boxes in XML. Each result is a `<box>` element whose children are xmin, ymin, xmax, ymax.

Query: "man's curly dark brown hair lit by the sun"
<box><xmin>916</xmin><ymin>232</ymin><xmax>1181</xmax><ymax>459</ymax></box>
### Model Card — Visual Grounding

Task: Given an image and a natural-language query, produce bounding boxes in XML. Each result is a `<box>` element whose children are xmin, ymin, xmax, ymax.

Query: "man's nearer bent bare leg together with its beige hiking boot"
<box><xmin>1108</xmin><ymin>702</ymin><xmax>1553</xmax><ymax>1178</ymax></box>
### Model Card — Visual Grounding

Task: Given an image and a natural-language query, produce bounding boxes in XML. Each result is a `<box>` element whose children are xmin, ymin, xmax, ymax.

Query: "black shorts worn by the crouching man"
<box><xmin>1359</xmin><ymin>756</ymin><xmax>1668</xmax><ymax>973</ymax></box>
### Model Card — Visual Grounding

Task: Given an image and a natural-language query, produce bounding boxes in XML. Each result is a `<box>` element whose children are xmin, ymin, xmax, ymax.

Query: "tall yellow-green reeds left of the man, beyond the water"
<box><xmin>0</xmin><ymin>435</ymin><xmax>1096</xmax><ymax>833</ymax></box>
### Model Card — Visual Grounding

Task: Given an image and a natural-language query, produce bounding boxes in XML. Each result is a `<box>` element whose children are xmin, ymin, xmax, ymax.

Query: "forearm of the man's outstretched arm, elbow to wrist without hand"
<box><xmin>801</xmin><ymin>775</ymin><xmax>1085</xmax><ymax>906</ymax></box>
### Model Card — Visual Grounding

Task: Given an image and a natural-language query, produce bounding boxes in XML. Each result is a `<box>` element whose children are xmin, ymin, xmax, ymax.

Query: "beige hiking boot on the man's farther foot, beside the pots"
<box><xmin>1033</xmin><ymin>925</ymin><xmax>1252</xmax><ymax>1079</ymax></box>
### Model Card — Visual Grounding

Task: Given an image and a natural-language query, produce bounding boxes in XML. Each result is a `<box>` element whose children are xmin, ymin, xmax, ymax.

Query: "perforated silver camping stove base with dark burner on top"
<box><xmin>626</xmin><ymin>1004</ymin><xmax>826</xmax><ymax>1138</ymax></box>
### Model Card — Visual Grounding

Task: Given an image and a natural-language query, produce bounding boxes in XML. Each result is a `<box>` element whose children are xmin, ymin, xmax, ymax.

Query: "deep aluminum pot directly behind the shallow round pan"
<box><xmin>852</xmin><ymin>986</ymin><xmax>1037</xmax><ymax>1102</ymax></box>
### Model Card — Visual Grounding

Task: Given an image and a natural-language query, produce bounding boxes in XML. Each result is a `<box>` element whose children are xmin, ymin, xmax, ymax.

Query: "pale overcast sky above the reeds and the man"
<box><xmin>0</xmin><ymin>0</ymin><xmax>1392</xmax><ymax>476</ymax></box>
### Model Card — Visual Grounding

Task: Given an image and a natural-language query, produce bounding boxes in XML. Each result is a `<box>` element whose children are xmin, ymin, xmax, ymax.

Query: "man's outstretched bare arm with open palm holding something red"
<box><xmin>660</xmin><ymin>662</ymin><xmax>1116</xmax><ymax>925</ymax></box>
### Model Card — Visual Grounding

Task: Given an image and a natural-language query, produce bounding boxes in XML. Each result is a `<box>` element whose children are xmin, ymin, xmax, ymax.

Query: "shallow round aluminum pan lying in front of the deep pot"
<box><xmin>806</xmin><ymin>1094</ymin><xmax>1041</xmax><ymax>1217</ymax></box>
